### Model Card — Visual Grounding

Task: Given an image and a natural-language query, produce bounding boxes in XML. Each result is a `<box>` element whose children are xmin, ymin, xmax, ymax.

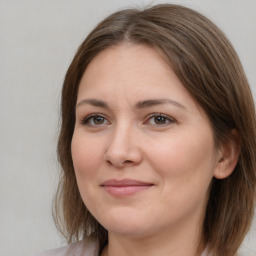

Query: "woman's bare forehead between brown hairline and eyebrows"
<box><xmin>77</xmin><ymin>43</ymin><xmax>205</xmax><ymax>116</ymax></box>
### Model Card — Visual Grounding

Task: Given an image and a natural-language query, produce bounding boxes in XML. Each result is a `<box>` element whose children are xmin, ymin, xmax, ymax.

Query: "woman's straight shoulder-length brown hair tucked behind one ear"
<box><xmin>55</xmin><ymin>4</ymin><xmax>256</xmax><ymax>256</ymax></box>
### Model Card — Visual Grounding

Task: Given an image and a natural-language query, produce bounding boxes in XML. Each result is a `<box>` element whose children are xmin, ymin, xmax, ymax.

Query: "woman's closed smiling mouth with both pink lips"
<box><xmin>101</xmin><ymin>179</ymin><xmax>154</xmax><ymax>197</ymax></box>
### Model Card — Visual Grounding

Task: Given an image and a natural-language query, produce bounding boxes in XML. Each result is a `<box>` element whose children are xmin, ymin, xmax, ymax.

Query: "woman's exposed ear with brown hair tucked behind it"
<box><xmin>213</xmin><ymin>129</ymin><xmax>240</xmax><ymax>179</ymax></box>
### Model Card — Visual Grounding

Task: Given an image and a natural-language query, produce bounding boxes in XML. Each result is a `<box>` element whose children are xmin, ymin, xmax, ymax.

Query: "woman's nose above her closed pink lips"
<box><xmin>104</xmin><ymin>125</ymin><xmax>142</xmax><ymax>168</ymax></box>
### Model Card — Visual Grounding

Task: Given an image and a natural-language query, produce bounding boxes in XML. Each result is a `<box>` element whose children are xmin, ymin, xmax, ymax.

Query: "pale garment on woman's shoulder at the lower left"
<box><xmin>35</xmin><ymin>240</ymin><xmax>99</xmax><ymax>256</ymax></box>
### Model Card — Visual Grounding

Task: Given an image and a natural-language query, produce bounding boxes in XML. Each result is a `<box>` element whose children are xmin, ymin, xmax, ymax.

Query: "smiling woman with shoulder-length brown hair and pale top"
<box><xmin>36</xmin><ymin>4</ymin><xmax>256</xmax><ymax>256</ymax></box>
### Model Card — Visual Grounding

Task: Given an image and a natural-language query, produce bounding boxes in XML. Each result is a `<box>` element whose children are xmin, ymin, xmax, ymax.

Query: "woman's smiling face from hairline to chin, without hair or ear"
<box><xmin>72</xmin><ymin>44</ymin><xmax>218</xmax><ymax>237</ymax></box>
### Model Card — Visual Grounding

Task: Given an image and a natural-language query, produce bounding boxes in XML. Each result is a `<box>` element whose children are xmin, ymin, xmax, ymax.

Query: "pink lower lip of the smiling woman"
<box><xmin>103</xmin><ymin>185</ymin><xmax>152</xmax><ymax>197</ymax></box>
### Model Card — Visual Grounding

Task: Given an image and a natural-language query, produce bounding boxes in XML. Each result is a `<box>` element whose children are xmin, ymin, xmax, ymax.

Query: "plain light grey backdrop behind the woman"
<box><xmin>0</xmin><ymin>0</ymin><xmax>256</xmax><ymax>256</ymax></box>
